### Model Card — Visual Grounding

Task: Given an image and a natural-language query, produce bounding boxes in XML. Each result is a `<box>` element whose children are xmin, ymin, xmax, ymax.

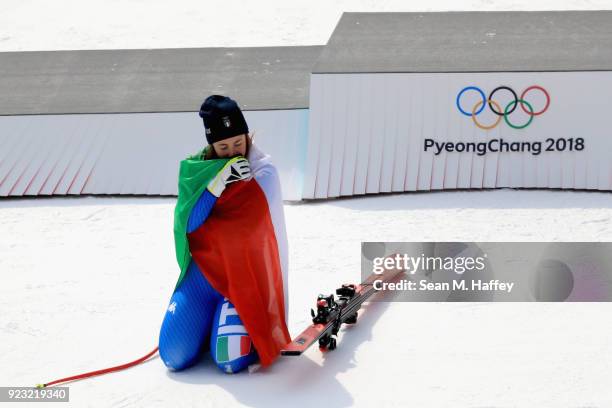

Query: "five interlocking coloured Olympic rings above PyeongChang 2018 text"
<box><xmin>456</xmin><ymin>85</ymin><xmax>550</xmax><ymax>130</ymax></box>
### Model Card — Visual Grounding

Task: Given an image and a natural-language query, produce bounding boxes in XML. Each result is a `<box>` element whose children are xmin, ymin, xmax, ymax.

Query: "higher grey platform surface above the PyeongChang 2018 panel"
<box><xmin>313</xmin><ymin>11</ymin><xmax>612</xmax><ymax>73</ymax></box>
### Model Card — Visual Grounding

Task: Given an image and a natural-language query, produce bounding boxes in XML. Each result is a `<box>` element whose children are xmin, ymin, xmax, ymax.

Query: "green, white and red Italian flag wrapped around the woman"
<box><xmin>174</xmin><ymin>145</ymin><xmax>291</xmax><ymax>366</ymax></box>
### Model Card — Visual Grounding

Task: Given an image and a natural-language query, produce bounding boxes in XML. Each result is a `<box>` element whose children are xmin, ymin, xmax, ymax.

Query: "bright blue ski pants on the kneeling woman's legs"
<box><xmin>159</xmin><ymin>260</ymin><xmax>259</xmax><ymax>373</ymax></box>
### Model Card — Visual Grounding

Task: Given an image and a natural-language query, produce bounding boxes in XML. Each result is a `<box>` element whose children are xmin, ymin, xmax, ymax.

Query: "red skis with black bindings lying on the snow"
<box><xmin>281</xmin><ymin>264</ymin><xmax>402</xmax><ymax>356</ymax></box>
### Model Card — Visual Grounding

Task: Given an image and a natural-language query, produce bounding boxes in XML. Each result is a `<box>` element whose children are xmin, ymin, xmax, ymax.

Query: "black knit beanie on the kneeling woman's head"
<box><xmin>200</xmin><ymin>95</ymin><xmax>249</xmax><ymax>144</ymax></box>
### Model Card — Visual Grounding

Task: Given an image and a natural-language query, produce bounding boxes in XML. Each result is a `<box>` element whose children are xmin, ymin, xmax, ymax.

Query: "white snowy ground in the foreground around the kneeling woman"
<box><xmin>0</xmin><ymin>189</ymin><xmax>612</xmax><ymax>407</ymax></box>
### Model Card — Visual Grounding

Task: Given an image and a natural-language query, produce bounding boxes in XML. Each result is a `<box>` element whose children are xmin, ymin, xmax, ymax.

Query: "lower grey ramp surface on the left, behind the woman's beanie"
<box><xmin>0</xmin><ymin>46</ymin><xmax>322</xmax><ymax>115</ymax></box>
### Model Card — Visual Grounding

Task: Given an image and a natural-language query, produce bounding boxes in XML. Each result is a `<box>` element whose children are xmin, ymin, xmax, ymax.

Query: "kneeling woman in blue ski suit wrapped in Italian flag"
<box><xmin>159</xmin><ymin>95</ymin><xmax>290</xmax><ymax>373</ymax></box>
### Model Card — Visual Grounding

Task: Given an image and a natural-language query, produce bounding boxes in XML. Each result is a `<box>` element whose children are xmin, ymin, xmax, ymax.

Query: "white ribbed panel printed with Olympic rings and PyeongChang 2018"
<box><xmin>303</xmin><ymin>71</ymin><xmax>612</xmax><ymax>198</ymax></box>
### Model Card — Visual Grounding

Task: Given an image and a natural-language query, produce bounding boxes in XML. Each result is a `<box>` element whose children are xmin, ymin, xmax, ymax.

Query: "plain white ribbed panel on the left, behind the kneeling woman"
<box><xmin>0</xmin><ymin>109</ymin><xmax>308</xmax><ymax>200</ymax></box>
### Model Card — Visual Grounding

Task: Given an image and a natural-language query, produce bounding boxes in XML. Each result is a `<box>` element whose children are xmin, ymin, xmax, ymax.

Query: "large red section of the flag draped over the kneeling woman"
<box><xmin>187</xmin><ymin>179</ymin><xmax>291</xmax><ymax>367</ymax></box>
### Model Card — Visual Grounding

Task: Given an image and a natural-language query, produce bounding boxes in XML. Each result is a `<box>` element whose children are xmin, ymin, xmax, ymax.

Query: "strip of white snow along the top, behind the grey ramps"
<box><xmin>0</xmin><ymin>0</ymin><xmax>612</xmax><ymax>51</ymax></box>
